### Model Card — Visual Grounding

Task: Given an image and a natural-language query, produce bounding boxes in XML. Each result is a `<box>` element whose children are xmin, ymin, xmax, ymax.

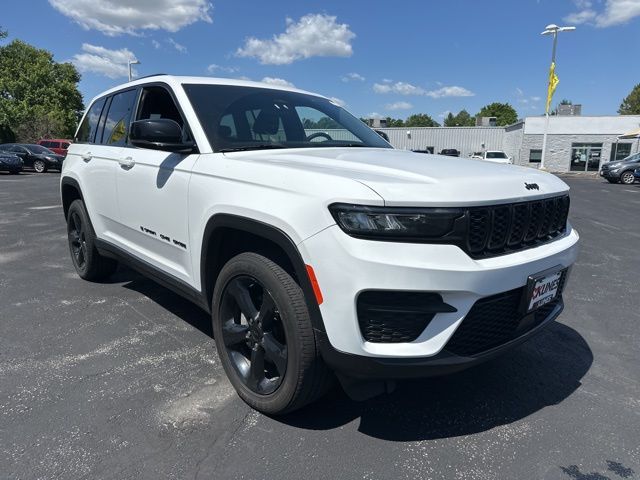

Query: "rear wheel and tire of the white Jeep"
<box><xmin>67</xmin><ymin>200</ymin><xmax>118</xmax><ymax>281</ymax></box>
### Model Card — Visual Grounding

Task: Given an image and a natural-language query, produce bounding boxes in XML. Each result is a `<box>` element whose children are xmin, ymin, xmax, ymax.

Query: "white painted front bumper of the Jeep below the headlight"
<box><xmin>299</xmin><ymin>225</ymin><xmax>579</xmax><ymax>362</ymax></box>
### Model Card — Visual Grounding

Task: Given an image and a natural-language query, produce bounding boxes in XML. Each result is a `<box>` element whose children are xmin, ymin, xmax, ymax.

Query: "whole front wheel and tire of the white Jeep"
<box><xmin>212</xmin><ymin>253</ymin><xmax>332</xmax><ymax>415</ymax></box>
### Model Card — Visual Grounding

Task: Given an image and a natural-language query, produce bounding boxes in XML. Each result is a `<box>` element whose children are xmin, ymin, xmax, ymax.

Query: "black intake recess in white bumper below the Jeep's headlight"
<box><xmin>357</xmin><ymin>290</ymin><xmax>456</xmax><ymax>343</ymax></box>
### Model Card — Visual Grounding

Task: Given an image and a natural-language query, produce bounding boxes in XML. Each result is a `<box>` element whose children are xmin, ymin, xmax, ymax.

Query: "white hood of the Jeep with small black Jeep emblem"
<box><xmin>225</xmin><ymin>147</ymin><xmax>569</xmax><ymax>206</ymax></box>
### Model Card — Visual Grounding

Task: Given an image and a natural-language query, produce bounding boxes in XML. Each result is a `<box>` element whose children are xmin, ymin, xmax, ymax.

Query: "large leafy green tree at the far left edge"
<box><xmin>0</xmin><ymin>40</ymin><xmax>83</xmax><ymax>142</ymax></box>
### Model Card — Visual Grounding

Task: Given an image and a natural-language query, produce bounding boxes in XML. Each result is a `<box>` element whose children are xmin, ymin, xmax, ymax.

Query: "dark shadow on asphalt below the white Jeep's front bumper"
<box><xmin>278</xmin><ymin>323</ymin><xmax>593</xmax><ymax>442</ymax></box>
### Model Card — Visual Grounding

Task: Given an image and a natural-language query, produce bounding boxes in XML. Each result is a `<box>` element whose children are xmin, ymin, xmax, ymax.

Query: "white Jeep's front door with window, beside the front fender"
<box><xmin>117</xmin><ymin>85</ymin><xmax>198</xmax><ymax>283</ymax></box>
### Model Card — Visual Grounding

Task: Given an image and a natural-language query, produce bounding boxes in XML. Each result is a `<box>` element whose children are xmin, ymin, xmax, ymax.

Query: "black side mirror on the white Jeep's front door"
<box><xmin>129</xmin><ymin>118</ymin><xmax>195</xmax><ymax>153</ymax></box>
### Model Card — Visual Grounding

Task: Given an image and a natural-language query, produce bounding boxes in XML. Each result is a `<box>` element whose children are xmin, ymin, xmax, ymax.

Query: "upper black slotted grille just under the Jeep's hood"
<box><xmin>466</xmin><ymin>195</ymin><xmax>569</xmax><ymax>258</ymax></box>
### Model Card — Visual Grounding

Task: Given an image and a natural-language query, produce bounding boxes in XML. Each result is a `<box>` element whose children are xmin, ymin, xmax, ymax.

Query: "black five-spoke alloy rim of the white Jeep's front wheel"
<box><xmin>219</xmin><ymin>275</ymin><xmax>288</xmax><ymax>395</ymax></box>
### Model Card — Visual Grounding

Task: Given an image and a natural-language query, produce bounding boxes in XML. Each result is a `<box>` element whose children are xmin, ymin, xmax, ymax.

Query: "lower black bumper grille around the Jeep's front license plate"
<box><xmin>445</xmin><ymin>272</ymin><xmax>567</xmax><ymax>357</ymax></box>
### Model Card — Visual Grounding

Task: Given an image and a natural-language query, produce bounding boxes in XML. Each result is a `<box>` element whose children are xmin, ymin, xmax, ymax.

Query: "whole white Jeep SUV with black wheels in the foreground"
<box><xmin>61</xmin><ymin>75</ymin><xmax>578</xmax><ymax>413</ymax></box>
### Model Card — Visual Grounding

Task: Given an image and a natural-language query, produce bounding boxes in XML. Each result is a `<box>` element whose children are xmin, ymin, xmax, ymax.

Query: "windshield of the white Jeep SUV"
<box><xmin>184</xmin><ymin>84</ymin><xmax>392</xmax><ymax>152</ymax></box>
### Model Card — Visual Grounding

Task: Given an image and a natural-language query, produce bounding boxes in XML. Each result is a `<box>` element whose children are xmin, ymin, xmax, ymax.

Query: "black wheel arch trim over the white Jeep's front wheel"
<box><xmin>200</xmin><ymin>214</ymin><xmax>325</xmax><ymax>332</ymax></box>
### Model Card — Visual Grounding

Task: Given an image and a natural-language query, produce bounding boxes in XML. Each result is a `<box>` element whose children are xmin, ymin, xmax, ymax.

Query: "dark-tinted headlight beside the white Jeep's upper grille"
<box><xmin>329</xmin><ymin>203</ymin><xmax>464</xmax><ymax>241</ymax></box>
